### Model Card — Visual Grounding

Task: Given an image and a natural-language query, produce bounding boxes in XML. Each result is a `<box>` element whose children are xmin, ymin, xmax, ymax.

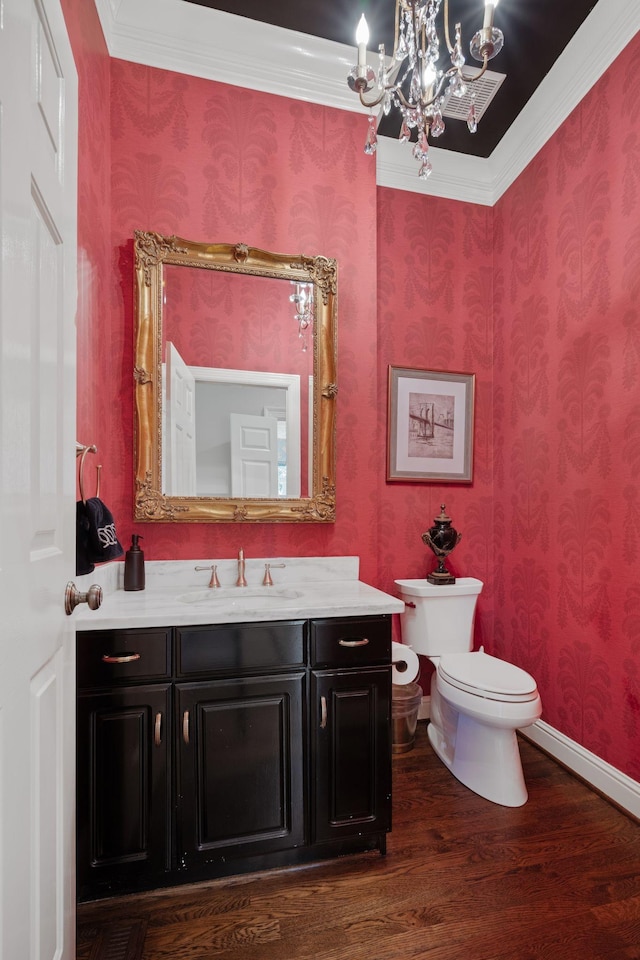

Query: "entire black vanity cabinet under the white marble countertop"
<box><xmin>77</xmin><ymin>615</ymin><xmax>391</xmax><ymax>900</ymax></box>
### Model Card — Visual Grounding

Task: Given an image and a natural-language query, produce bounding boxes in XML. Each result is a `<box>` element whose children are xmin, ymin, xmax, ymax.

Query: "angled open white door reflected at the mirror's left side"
<box><xmin>162</xmin><ymin>342</ymin><xmax>196</xmax><ymax>497</ymax></box>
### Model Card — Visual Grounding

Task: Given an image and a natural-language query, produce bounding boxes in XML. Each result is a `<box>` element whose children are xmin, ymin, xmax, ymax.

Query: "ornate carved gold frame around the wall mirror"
<box><xmin>134</xmin><ymin>230</ymin><xmax>338</xmax><ymax>523</ymax></box>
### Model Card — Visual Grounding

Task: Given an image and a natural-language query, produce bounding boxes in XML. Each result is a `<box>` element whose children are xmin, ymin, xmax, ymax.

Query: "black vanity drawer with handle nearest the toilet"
<box><xmin>311</xmin><ymin>615</ymin><xmax>391</xmax><ymax>667</ymax></box>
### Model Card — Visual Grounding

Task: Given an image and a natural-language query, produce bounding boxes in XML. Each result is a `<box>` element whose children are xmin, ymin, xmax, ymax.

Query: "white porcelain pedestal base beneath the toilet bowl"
<box><xmin>427</xmin><ymin>714</ymin><xmax>528</xmax><ymax>807</ymax></box>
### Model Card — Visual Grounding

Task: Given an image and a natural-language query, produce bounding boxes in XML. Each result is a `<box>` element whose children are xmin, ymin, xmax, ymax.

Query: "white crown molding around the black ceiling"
<box><xmin>95</xmin><ymin>0</ymin><xmax>640</xmax><ymax>206</ymax></box>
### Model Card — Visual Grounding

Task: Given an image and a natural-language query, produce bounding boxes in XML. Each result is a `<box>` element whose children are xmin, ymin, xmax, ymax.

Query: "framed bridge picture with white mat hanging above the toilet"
<box><xmin>387</xmin><ymin>367</ymin><xmax>475</xmax><ymax>483</ymax></box>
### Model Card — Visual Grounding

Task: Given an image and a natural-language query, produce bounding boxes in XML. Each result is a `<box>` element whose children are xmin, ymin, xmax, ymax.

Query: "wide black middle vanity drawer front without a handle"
<box><xmin>176</xmin><ymin>620</ymin><xmax>306</xmax><ymax>677</ymax></box>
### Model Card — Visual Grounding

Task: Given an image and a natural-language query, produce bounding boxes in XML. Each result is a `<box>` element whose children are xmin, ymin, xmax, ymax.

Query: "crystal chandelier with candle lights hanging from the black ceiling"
<box><xmin>348</xmin><ymin>0</ymin><xmax>504</xmax><ymax>178</ymax></box>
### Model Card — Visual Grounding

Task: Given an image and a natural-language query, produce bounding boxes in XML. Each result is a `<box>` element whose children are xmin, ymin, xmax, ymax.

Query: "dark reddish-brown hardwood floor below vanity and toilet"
<box><xmin>77</xmin><ymin>723</ymin><xmax>640</xmax><ymax>960</ymax></box>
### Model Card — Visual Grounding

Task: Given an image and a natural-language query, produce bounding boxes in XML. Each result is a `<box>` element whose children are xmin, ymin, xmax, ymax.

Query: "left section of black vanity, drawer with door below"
<box><xmin>76</xmin><ymin>630</ymin><xmax>172</xmax><ymax>900</ymax></box>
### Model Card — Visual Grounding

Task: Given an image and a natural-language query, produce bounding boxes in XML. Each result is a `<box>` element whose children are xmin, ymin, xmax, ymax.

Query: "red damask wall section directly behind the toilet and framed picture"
<box><xmin>378</xmin><ymin>189</ymin><xmax>501</xmax><ymax>693</ymax></box>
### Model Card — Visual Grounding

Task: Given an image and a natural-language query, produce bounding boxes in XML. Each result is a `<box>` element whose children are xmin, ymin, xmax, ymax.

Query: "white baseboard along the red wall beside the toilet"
<box><xmin>418</xmin><ymin>696</ymin><xmax>640</xmax><ymax>820</ymax></box>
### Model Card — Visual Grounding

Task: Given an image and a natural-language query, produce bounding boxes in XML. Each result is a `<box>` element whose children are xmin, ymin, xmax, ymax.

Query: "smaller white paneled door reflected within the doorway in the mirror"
<box><xmin>229</xmin><ymin>413</ymin><xmax>278</xmax><ymax>497</ymax></box>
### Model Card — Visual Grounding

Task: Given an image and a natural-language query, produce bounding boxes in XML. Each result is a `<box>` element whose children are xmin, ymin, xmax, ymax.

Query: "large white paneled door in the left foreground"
<box><xmin>0</xmin><ymin>0</ymin><xmax>78</xmax><ymax>960</ymax></box>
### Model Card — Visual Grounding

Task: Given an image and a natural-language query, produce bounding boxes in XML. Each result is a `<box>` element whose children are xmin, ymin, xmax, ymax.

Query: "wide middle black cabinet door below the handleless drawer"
<box><xmin>176</xmin><ymin>671</ymin><xmax>305</xmax><ymax>868</ymax></box>
